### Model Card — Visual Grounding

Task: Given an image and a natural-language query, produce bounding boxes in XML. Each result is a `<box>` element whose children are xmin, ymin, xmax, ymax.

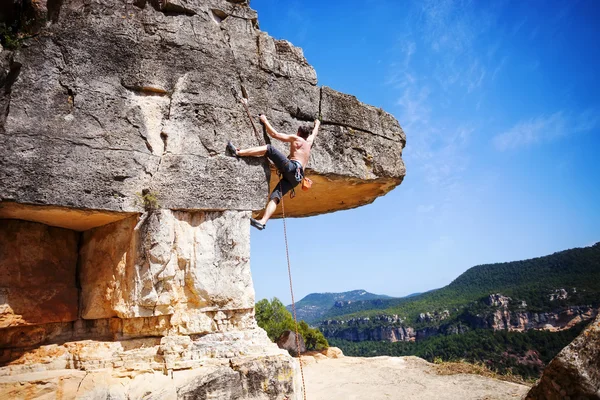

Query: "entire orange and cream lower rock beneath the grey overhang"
<box><xmin>0</xmin><ymin>210</ymin><xmax>299</xmax><ymax>399</ymax></box>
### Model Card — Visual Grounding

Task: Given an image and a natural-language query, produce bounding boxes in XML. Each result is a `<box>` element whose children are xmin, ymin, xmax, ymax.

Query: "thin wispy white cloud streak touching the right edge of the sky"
<box><xmin>492</xmin><ymin>110</ymin><xmax>600</xmax><ymax>151</ymax></box>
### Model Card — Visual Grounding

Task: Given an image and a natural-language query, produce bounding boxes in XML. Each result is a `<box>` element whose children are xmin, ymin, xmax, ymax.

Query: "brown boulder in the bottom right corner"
<box><xmin>527</xmin><ymin>315</ymin><xmax>600</xmax><ymax>400</ymax></box>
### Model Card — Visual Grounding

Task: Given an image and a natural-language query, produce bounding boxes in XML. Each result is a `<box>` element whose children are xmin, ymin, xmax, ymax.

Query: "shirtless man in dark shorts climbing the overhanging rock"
<box><xmin>227</xmin><ymin>115</ymin><xmax>321</xmax><ymax>230</ymax></box>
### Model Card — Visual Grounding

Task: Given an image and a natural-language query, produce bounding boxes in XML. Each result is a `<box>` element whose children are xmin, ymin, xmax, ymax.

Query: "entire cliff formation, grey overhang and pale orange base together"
<box><xmin>0</xmin><ymin>0</ymin><xmax>406</xmax><ymax>399</ymax></box>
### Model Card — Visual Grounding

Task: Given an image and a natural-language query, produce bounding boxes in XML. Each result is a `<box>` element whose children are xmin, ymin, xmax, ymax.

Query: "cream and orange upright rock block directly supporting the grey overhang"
<box><xmin>80</xmin><ymin>210</ymin><xmax>254</xmax><ymax>328</ymax></box>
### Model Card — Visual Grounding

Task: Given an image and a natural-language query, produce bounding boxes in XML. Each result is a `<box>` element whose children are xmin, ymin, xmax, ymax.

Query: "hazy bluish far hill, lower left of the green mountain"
<box><xmin>286</xmin><ymin>289</ymin><xmax>393</xmax><ymax>323</ymax></box>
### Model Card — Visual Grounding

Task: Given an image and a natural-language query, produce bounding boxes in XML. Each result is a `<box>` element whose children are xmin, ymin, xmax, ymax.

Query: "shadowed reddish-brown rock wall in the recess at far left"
<box><xmin>0</xmin><ymin>219</ymin><xmax>79</xmax><ymax>329</ymax></box>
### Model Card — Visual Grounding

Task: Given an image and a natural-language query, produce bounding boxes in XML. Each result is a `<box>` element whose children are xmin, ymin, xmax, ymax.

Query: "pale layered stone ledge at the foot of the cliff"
<box><xmin>0</xmin><ymin>327</ymin><xmax>300</xmax><ymax>400</ymax></box>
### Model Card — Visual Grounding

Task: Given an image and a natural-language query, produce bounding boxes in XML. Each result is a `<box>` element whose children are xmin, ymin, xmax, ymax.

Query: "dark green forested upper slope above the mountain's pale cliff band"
<box><xmin>321</xmin><ymin>242</ymin><xmax>600</xmax><ymax>324</ymax></box>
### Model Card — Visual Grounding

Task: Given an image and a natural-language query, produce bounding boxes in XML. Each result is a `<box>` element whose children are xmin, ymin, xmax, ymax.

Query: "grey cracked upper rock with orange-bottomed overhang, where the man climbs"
<box><xmin>0</xmin><ymin>0</ymin><xmax>405</xmax><ymax>216</ymax></box>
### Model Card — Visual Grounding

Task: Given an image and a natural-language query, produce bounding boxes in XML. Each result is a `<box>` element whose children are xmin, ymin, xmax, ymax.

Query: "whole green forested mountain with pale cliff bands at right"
<box><xmin>317</xmin><ymin>243</ymin><xmax>600</xmax><ymax>378</ymax></box>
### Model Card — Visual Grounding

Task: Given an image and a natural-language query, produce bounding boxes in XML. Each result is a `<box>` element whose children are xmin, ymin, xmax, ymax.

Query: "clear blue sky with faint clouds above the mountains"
<box><xmin>251</xmin><ymin>0</ymin><xmax>600</xmax><ymax>304</ymax></box>
